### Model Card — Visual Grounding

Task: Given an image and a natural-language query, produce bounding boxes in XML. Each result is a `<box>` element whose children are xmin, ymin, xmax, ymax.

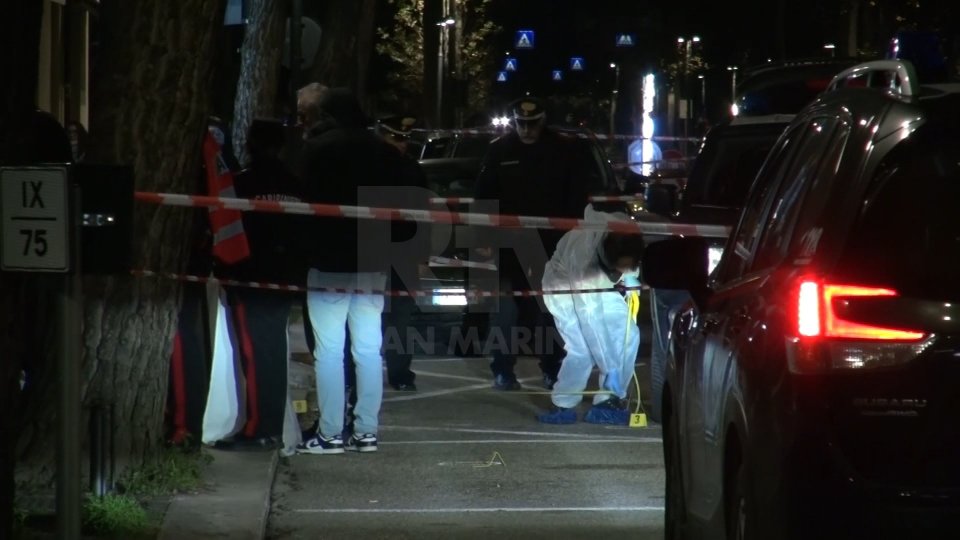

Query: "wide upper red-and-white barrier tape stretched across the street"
<box><xmin>134</xmin><ymin>191</ymin><xmax>730</xmax><ymax>238</ymax></box>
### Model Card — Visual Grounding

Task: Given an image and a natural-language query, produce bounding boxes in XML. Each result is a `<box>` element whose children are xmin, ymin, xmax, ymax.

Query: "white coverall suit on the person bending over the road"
<box><xmin>543</xmin><ymin>206</ymin><xmax>640</xmax><ymax>408</ymax></box>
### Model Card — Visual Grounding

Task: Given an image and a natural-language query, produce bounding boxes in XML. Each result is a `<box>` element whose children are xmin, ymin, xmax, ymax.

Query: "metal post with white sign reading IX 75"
<box><xmin>0</xmin><ymin>166</ymin><xmax>81</xmax><ymax>540</ymax></box>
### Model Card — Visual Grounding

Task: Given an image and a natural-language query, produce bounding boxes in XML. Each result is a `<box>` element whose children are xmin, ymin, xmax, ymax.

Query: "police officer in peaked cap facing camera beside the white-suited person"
<box><xmin>475</xmin><ymin>97</ymin><xmax>588</xmax><ymax>390</ymax></box>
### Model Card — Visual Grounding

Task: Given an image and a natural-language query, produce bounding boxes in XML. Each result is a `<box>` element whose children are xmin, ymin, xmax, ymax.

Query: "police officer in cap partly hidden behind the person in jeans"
<box><xmin>377</xmin><ymin>116</ymin><xmax>430</xmax><ymax>392</ymax></box>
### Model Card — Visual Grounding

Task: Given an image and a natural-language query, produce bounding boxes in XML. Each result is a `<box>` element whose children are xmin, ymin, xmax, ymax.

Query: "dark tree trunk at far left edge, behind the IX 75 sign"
<box><xmin>0</xmin><ymin>2</ymin><xmax>43</xmax><ymax>538</ymax></box>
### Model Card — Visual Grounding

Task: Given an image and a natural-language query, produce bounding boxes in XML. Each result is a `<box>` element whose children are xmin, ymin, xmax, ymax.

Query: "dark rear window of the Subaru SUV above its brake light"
<box><xmin>840</xmin><ymin>126</ymin><xmax>960</xmax><ymax>301</ymax></box>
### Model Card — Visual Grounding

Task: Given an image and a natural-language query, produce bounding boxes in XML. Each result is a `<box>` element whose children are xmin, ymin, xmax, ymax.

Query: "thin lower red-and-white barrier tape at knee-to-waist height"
<box><xmin>130</xmin><ymin>270</ymin><xmax>649</xmax><ymax>298</ymax></box>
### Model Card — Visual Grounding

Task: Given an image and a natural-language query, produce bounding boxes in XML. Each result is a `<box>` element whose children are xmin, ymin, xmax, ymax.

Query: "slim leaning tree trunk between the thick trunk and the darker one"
<box><xmin>233</xmin><ymin>0</ymin><xmax>285</xmax><ymax>163</ymax></box>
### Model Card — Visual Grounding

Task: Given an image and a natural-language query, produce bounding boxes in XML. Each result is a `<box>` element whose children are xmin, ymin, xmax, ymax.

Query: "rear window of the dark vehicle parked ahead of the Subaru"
<box><xmin>684</xmin><ymin>124</ymin><xmax>786</xmax><ymax>208</ymax></box>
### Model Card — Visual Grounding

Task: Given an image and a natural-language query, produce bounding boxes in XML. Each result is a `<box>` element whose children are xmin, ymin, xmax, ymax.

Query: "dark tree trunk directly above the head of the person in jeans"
<box><xmin>304</xmin><ymin>0</ymin><xmax>377</xmax><ymax>103</ymax></box>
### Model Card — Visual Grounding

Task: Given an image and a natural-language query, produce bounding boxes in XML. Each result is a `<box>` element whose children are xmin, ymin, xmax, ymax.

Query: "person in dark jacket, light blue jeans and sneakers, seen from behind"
<box><xmin>297</xmin><ymin>84</ymin><xmax>426</xmax><ymax>454</ymax></box>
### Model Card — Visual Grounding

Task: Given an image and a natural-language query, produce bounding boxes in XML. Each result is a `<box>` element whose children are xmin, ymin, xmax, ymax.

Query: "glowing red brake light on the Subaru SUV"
<box><xmin>797</xmin><ymin>280</ymin><xmax>924</xmax><ymax>341</ymax></box>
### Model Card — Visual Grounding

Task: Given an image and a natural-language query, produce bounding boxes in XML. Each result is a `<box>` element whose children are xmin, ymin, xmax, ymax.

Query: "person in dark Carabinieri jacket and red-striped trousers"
<box><xmin>218</xmin><ymin>119</ymin><xmax>305</xmax><ymax>448</ymax></box>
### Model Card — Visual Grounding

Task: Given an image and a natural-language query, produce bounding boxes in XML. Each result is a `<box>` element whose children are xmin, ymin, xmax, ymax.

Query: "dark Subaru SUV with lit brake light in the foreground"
<box><xmin>644</xmin><ymin>61</ymin><xmax>960</xmax><ymax>540</ymax></box>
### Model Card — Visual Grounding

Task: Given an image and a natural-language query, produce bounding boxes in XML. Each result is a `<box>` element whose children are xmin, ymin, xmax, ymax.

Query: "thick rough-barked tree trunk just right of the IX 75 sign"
<box><xmin>17</xmin><ymin>0</ymin><xmax>225</xmax><ymax>494</ymax></box>
